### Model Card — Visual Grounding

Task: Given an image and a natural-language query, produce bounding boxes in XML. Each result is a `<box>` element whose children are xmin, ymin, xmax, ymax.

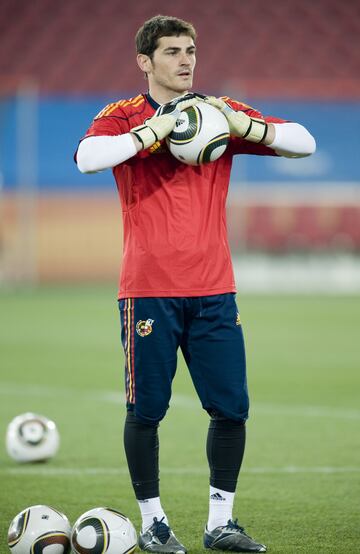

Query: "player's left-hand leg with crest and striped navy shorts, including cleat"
<box><xmin>119</xmin><ymin>298</ymin><xmax>186</xmax><ymax>554</ymax></box>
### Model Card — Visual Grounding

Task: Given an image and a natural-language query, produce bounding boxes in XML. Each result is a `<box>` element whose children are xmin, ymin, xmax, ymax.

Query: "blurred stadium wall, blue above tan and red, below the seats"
<box><xmin>0</xmin><ymin>96</ymin><xmax>360</xmax><ymax>282</ymax></box>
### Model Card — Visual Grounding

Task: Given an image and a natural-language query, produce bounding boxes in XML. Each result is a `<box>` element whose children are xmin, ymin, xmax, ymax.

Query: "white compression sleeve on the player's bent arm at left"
<box><xmin>76</xmin><ymin>133</ymin><xmax>137</xmax><ymax>173</ymax></box>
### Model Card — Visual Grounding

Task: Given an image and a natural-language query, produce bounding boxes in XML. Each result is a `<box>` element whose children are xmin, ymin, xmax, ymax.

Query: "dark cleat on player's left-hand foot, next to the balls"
<box><xmin>139</xmin><ymin>517</ymin><xmax>186</xmax><ymax>554</ymax></box>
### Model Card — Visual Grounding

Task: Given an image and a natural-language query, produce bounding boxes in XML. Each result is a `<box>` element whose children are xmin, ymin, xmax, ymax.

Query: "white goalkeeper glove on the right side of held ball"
<box><xmin>204</xmin><ymin>96</ymin><xmax>268</xmax><ymax>142</ymax></box>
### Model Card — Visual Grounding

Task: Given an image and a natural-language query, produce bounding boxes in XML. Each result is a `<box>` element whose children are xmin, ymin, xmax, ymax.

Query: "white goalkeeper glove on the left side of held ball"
<box><xmin>130</xmin><ymin>95</ymin><xmax>199</xmax><ymax>150</ymax></box>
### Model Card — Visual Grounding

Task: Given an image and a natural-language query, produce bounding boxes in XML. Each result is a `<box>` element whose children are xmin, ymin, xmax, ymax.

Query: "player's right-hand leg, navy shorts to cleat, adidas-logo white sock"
<box><xmin>181</xmin><ymin>294</ymin><xmax>266</xmax><ymax>552</ymax></box>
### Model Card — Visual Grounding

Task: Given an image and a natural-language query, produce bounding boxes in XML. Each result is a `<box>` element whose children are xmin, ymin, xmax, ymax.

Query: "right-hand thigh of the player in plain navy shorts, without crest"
<box><xmin>182</xmin><ymin>294</ymin><xmax>249</xmax><ymax>421</ymax></box>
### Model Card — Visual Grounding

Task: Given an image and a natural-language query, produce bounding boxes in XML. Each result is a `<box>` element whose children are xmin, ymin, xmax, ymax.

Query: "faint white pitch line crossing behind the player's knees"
<box><xmin>0</xmin><ymin>383</ymin><xmax>360</xmax><ymax>421</ymax></box>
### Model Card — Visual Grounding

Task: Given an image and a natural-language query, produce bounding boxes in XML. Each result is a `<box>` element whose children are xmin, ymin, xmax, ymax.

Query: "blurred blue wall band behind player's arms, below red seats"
<box><xmin>0</xmin><ymin>94</ymin><xmax>360</xmax><ymax>185</ymax></box>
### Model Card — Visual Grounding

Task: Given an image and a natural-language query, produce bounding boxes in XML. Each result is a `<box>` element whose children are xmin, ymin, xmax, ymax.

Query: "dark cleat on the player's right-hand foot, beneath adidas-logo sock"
<box><xmin>204</xmin><ymin>519</ymin><xmax>266</xmax><ymax>552</ymax></box>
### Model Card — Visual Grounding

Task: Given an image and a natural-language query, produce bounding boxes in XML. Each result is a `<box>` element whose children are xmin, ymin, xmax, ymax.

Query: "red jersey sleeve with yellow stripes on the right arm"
<box><xmin>222</xmin><ymin>96</ymin><xmax>287</xmax><ymax>156</ymax></box>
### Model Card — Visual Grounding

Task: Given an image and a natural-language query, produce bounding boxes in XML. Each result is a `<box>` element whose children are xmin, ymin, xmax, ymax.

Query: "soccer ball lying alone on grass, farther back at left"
<box><xmin>6</xmin><ymin>413</ymin><xmax>60</xmax><ymax>462</ymax></box>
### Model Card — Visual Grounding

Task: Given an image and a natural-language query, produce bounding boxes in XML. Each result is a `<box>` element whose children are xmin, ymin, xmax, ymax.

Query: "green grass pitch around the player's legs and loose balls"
<box><xmin>0</xmin><ymin>287</ymin><xmax>360</xmax><ymax>554</ymax></box>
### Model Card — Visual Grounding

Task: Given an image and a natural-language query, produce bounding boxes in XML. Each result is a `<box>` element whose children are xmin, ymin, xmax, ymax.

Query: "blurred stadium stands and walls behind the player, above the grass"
<box><xmin>0</xmin><ymin>0</ymin><xmax>360</xmax><ymax>292</ymax></box>
